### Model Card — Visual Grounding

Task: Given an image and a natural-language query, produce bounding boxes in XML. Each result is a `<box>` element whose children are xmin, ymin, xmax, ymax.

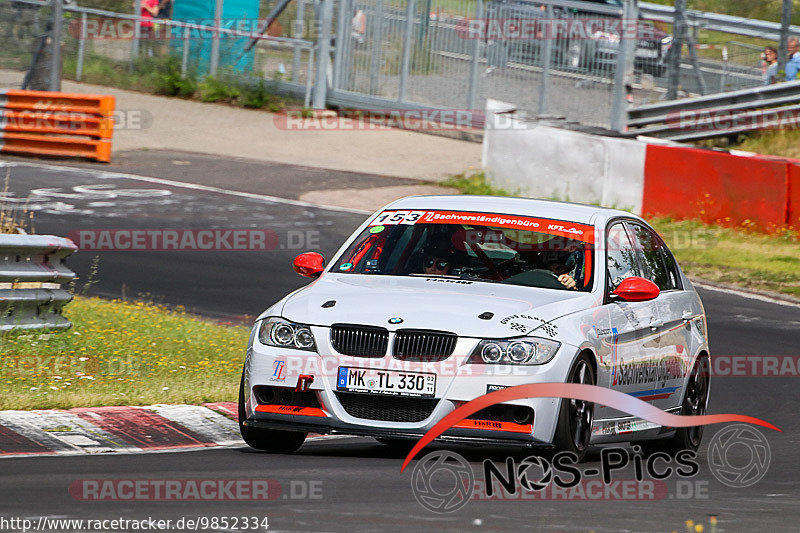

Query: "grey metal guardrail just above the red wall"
<box><xmin>628</xmin><ymin>81</ymin><xmax>800</xmax><ymax>141</ymax></box>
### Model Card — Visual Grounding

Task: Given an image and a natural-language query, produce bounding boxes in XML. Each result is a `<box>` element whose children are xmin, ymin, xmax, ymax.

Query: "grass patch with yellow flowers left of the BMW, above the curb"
<box><xmin>0</xmin><ymin>297</ymin><xmax>249</xmax><ymax>410</ymax></box>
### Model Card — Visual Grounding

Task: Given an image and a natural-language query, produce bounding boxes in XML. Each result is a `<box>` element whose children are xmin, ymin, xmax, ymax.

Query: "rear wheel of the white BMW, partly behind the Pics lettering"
<box><xmin>633</xmin><ymin>356</ymin><xmax>710</xmax><ymax>455</ymax></box>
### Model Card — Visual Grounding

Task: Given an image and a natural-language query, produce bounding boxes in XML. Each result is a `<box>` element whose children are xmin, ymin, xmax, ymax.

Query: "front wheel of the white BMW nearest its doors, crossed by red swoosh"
<box><xmin>553</xmin><ymin>353</ymin><xmax>596</xmax><ymax>460</ymax></box>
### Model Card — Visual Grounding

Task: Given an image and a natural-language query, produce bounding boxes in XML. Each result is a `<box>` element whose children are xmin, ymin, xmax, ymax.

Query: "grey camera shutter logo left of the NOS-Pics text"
<box><xmin>411</xmin><ymin>450</ymin><xmax>475</xmax><ymax>513</ymax></box>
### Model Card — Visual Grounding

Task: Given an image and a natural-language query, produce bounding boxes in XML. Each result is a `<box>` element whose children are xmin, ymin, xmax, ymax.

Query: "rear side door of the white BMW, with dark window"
<box><xmin>628</xmin><ymin>222</ymin><xmax>697</xmax><ymax>409</ymax></box>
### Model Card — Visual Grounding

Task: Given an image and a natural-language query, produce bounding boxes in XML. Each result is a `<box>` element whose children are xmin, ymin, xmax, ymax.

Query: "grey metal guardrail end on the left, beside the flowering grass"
<box><xmin>0</xmin><ymin>234</ymin><xmax>78</xmax><ymax>331</ymax></box>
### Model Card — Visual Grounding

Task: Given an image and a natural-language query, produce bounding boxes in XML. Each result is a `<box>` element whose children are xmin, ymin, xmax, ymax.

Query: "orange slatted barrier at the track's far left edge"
<box><xmin>0</xmin><ymin>90</ymin><xmax>114</xmax><ymax>163</ymax></box>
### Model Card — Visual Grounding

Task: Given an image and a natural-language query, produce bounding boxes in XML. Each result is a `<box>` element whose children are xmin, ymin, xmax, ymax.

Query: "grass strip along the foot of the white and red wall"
<box><xmin>442</xmin><ymin>172</ymin><xmax>800</xmax><ymax>297</ymax></box>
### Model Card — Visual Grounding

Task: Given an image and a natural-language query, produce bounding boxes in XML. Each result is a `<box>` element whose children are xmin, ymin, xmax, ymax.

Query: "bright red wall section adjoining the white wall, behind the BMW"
<box><xmin>642</xmin><ymin>144</ymin><xmax>788</xmax><ymax>229</ymax></box>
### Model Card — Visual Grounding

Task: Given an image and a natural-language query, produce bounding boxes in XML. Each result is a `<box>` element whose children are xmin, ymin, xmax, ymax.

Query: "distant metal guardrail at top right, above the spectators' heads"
<box><xmin>639</xmin><ymin>2</ymin><xmax>800</xmax><ymax>41</ymax></box>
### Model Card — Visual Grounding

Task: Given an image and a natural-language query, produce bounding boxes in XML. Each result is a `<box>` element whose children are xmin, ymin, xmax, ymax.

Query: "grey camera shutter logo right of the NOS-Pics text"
<box><xmin>708</xmin><ymin>424</ymin><xmax>771</xmax><ymax>489</ymax></box>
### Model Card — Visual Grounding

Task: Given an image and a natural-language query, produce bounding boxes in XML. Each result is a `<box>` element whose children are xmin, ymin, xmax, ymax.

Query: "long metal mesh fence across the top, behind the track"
<box><xmin>0</xmin><ymin>0</ymin><xmax>780</xmax><ymax>128</ymax></box>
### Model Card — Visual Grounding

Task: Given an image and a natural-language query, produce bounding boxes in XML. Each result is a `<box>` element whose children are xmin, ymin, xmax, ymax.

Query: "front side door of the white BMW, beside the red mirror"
<box><xmin>597</xmin><ymin>220</ymin><xmax>660</xmax><ymax>418</ymax></box>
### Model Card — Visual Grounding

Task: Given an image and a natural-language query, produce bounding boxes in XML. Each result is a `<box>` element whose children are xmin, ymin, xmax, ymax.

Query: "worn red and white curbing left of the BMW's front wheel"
<box><xmin>0</xmin><ymin>402</ymin><xmax>243</xmax><ymax>458</ymax></box>
